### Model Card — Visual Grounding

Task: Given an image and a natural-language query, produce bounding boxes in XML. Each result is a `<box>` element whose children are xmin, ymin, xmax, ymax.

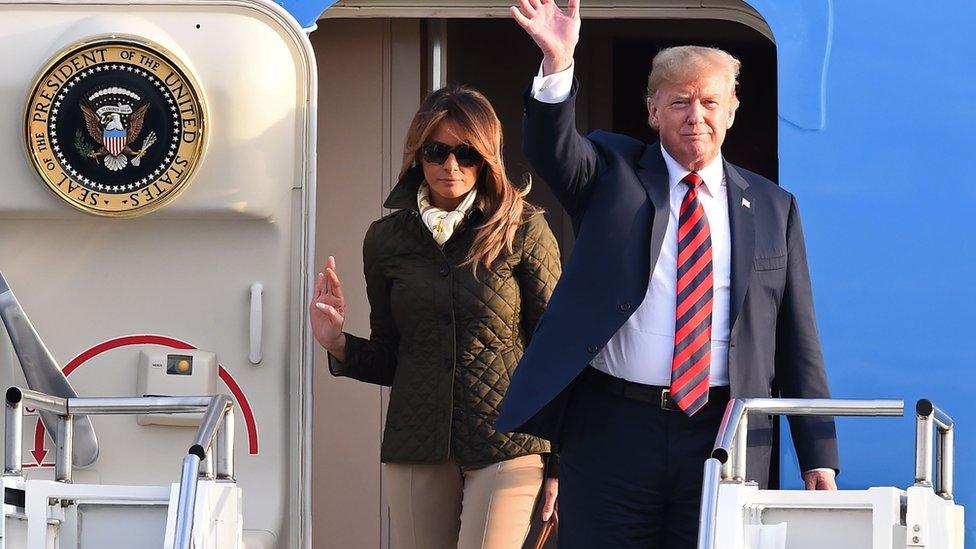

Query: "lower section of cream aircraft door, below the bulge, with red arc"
<box><xmin>0</xmin><ymin>215</ymin><xmax>292</xmax><ymax>532</ymax></box>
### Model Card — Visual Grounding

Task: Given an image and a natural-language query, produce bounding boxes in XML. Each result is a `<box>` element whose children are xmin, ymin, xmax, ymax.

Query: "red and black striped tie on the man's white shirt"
<box><xmin>671</xmin><ymin>172</ymin><xmax>712</xmax><ymax>416</ymax></box>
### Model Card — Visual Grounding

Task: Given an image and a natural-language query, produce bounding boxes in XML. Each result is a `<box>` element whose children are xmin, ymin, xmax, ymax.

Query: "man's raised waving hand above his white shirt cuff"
<box><xmin>511</xmin><ymin>0</ymin><xmax>580</xmax><ymax>75</ymax></box>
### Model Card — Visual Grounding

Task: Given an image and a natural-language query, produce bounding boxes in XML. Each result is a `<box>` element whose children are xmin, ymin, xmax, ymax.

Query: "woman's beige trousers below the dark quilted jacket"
<box><xmin>384</xmin><ymin>455</ymin><xmax>542</xmax><ymax>549</ymax></box>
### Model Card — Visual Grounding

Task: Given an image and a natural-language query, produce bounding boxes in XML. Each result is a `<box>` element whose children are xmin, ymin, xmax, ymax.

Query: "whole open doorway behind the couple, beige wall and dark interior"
<box><xmin>310</xmin><ymin>9</ymin><xmax>779</xmax><ymax>549</ymax></box>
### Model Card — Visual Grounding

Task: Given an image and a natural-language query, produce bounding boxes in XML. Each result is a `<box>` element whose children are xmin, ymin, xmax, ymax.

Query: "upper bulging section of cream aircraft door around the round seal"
<box><xmin>0</xmin><ymin>4</ymin><xmax>310</xmax><ymax>219</ymax></box>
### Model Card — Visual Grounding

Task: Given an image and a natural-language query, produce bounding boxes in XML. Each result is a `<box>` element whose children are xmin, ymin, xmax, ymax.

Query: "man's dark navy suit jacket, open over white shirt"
<box><xmin>495</xmin><ymin>85</ymin><xmax>839</xmax><ymax>485</ymax></box>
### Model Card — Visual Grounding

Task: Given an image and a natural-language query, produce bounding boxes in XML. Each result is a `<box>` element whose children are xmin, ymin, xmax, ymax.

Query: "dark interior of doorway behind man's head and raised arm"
<box><xmin>446</xmin><ymin>19</ymin><xmax>779</xmax><ymax>258</ymax></box>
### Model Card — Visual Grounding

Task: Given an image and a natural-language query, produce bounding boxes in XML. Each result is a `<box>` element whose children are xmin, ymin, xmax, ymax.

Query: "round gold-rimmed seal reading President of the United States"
<box><xmin>25</xmin><ymin>37</ymin><xmax>207</xmax><ymax>217</ymax></box>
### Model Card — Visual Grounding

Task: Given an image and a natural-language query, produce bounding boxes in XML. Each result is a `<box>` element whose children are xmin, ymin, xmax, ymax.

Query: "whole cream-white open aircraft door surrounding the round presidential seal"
<box><xmin>0</xmin><ymin>1</ymin><xmax>316</xmax><ymax>547</ymax></box>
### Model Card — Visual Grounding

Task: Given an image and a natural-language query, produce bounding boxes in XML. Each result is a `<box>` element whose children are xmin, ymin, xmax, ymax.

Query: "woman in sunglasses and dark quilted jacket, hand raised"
<box><xmin>310</xmin><ymin>86</ymin><xmax>560</xmax><ymax>549</ymax></box>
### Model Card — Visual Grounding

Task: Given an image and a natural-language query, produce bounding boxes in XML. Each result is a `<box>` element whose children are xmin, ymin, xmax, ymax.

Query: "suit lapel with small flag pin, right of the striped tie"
<box><xmin>725</xmin><ymin>162</ymin><xmax>756</xmax><ymax>330</ymax></box>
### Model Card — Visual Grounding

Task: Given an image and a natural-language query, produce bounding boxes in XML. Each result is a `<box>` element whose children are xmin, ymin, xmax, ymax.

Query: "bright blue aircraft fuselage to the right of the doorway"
<box><xmin>744</xmin><ymin>0</ymin><xmax>976</xmax><ymax>548</ymax></box>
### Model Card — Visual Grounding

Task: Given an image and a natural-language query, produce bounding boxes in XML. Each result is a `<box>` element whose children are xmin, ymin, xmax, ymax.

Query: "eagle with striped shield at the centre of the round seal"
<box><xmin>75</xmin><ymin>87</ymin><xmax>156</xmax><ymax>172</ymax></box>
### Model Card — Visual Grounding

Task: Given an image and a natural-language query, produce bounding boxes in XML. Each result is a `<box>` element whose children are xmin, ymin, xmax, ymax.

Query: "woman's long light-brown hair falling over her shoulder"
<box><xmin>400</xmin><ymin>84</ymin><xmax>541</xmax><ymax>270</ymax></box>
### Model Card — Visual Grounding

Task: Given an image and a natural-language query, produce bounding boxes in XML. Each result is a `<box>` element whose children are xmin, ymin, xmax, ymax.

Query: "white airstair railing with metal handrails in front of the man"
<box><xmin>698</xmin><ymin>399</ymin><xmax>964</xmax><ymax>549</ymax></box>
